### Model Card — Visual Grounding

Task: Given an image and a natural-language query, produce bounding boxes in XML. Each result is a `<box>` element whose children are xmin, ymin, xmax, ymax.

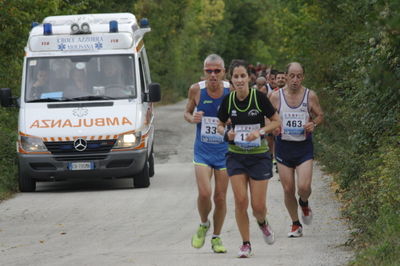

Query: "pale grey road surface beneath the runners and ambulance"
<box><xmin>0</xmin><ymin>102</ymin><xmax>352</xmax><ymax>266</ymax></box>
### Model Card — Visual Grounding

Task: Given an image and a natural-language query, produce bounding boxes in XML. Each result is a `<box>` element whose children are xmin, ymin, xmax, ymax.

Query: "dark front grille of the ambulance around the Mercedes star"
<box><xmin>44</xmin><ymin>139</ymin><xmax>116</xmax><ymax>156</ymax></box>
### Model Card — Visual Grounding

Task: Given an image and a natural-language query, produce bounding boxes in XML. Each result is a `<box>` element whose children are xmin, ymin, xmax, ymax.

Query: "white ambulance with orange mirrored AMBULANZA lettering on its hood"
<box><xmin>0</xmin><ymin>13</ymin><xmax>160</xmax><ymax>192</ymax></box>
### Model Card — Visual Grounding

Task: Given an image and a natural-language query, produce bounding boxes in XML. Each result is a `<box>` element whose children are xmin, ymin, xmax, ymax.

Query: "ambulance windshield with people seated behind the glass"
<box><xmin>25</xmin><ymin>55</ymin><xmax>137</xmax><ymax>102</ymax></box>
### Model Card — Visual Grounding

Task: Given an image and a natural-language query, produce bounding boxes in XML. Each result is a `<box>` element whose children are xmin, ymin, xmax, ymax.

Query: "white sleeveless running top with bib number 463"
<box><xmin>278</xmin><ymin>88</ymin><xmax>310</xmax><ymax>141</ymax></box>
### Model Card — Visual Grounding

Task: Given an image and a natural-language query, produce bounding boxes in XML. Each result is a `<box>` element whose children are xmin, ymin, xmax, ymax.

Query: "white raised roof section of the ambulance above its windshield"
<box><xmin>25</xmin><ymin>13</ymin><xmax>150</xmax><ymax>55</ymax></box>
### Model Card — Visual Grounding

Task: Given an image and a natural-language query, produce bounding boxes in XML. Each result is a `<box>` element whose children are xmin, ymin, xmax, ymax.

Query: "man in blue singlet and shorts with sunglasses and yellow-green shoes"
<box><xmin>184</xmin><ymin>54</ymin><xmax>229</xmax><ymax>253</ymax></box>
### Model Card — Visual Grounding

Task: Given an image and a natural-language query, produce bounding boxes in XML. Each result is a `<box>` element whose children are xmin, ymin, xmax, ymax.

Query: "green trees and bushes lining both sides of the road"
<box><xmin>0</xmin><ymin>0</ymin><xmax>400</xmax><ymax>265</ymax></box>
